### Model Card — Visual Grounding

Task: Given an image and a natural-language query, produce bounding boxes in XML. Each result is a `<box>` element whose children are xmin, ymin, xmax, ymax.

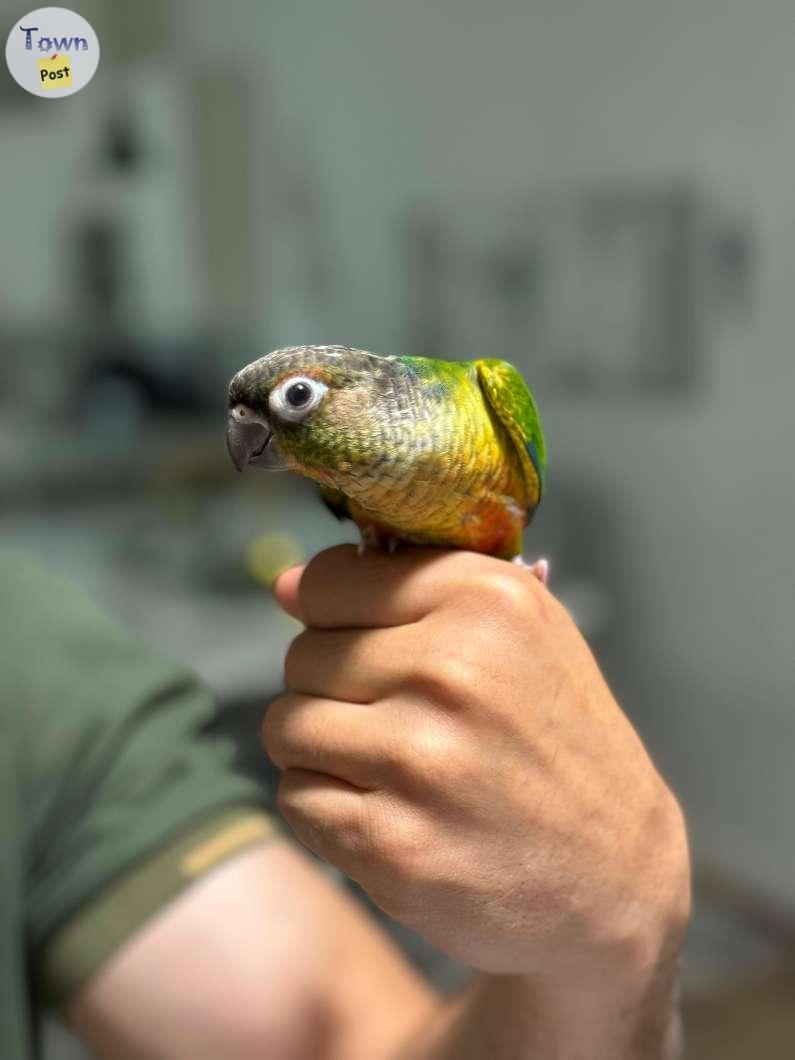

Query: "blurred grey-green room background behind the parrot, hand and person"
<box><xmin>0</xmin><ymin>0</ymin><xmax>795</xmax><ymax>1060</ymax></box>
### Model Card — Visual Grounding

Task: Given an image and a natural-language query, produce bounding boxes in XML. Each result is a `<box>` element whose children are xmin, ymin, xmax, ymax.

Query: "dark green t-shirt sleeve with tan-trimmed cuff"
<box><xmin>0</xmin><ymin>558</ymin><xmax>276</xmax><ymax>1001</ymax></box>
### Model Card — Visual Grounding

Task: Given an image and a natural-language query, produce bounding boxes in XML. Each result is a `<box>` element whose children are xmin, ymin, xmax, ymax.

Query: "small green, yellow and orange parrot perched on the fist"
<box><xmin>227</xmin><ymin>346</ymin><xmax>548</xmax><ymax>582</ymax></box>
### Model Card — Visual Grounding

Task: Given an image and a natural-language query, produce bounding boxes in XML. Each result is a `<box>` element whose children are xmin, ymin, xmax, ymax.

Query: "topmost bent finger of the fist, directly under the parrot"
<box><xmin>298</xmin><ymin>545</ymin><xmax>489</xmax><ymax>629</ymax></box>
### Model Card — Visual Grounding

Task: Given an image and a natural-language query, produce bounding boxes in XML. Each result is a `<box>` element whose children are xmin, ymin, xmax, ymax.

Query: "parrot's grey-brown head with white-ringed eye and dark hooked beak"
<box><xmin>227</xmin><ymin>346</ymin><xmax>390</xmax><ymax>482</ymax></box>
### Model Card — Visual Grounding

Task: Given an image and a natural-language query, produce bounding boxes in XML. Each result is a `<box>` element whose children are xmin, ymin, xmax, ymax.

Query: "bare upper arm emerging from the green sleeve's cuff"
<box><xmin>64</xmin><ymin>838</ymin><xmax>439</xmax><ymax>1060</ymax></box>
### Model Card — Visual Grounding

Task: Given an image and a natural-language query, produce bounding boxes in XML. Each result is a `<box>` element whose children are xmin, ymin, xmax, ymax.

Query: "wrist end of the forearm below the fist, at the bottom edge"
<box><xmin>390</xmin><ymin>967</ymin><xmax>681</xmax><ymax>1060</ymax></box>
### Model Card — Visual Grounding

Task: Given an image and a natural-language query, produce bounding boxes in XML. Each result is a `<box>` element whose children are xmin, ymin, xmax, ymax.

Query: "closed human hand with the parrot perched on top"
<box><xmin>264</xmin><ymin>546</ymin><xmax>689</xmax><ymax>991</ymax></box>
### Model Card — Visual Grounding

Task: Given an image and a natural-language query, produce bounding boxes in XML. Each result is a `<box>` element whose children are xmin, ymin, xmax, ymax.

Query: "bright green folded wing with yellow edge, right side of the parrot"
<box><xmin>475</xmin><ymin>358</ymin><xmax>547</xmax><ymax>509</ymax></box>
